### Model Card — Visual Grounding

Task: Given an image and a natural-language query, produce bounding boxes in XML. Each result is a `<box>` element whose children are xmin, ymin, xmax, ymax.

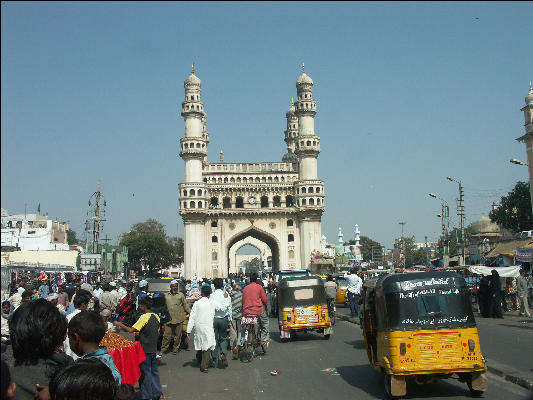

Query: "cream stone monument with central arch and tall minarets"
<box><xmin>179</xmin><ymin>66</ymin><xmax>325</xmax><ymax>278</ymax></box>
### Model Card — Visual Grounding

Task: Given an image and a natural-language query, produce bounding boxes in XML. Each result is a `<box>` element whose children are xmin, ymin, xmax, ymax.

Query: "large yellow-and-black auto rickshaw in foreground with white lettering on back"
<box><xmin>362</xmin><ymin>272</ymin><xmax>488</xmax><ymax>398</ymax></box>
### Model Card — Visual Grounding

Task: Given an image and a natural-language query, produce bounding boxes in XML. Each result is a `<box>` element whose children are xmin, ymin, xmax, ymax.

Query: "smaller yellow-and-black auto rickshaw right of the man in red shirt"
<box><xmin>278</xmin><ymin>276</ymin><xmax>333</xmax><ymax>342</ymax></box>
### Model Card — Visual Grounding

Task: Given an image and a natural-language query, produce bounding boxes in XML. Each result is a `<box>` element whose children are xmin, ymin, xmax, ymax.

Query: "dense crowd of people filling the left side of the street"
<box><xmin>1</xmin><ymin>273</ymin><xmax>273</xmax><ymax>400</ymax></box>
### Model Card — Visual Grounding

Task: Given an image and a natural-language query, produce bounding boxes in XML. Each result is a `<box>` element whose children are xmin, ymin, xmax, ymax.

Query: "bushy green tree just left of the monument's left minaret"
<box><xmin>120</xmin><ymin>219</ymin><xmax>183</xmax><ymax>273</ymax></box>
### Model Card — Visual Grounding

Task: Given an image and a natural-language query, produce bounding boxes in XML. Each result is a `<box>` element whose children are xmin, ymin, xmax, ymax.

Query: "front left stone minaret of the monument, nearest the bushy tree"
<box><xmin>180</xmin><ymin>64</ymin><xmax>209</xmax><ymax>276</ymax></box>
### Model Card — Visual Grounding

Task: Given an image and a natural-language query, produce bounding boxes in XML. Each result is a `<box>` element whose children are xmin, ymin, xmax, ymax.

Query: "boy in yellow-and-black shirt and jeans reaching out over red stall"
<box><xmin>114</xmin><ymin>296</ymin><xmax>163</xmax><ymax>400</ymax></box>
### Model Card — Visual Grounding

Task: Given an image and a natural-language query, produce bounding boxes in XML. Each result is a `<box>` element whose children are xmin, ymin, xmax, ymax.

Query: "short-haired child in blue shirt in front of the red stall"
<box><xmin>68</xmin><ymin>311</ymin><xmax>122</xmax><ymax>386</ymax></box>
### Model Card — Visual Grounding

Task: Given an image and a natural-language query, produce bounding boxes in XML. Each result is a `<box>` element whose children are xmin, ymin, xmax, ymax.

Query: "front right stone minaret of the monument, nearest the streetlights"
<box><xmin>294</xmin><ymin>64</ymin><xmax>324</xmax><ymax>268</ymax></box>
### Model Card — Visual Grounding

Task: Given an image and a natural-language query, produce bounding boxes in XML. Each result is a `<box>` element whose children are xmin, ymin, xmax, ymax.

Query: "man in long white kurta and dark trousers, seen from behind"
<box><xmin>187</xmin><ymin>286</ymin><xmax>231</xmax><ymax>372</ymax></box>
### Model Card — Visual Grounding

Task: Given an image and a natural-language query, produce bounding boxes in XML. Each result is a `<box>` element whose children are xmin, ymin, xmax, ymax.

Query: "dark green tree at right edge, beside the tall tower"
<box><xmin>489</xmin><ymin>181</ymin><xmax>533</xmax><ymax>233</ymax></box>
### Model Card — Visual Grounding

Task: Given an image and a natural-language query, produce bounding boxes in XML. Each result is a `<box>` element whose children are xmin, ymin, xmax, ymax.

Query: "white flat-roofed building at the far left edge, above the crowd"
<box><xmin>1</xmin><ymin>209</ymin><xmax>69</xmax><ymax>251</ymax></box>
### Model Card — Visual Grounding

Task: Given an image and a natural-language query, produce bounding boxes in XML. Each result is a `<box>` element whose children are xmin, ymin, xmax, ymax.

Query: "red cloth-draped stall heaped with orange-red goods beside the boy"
<box><xmin>100</xmin><ymin>332</ymin><xmax>146</xmax><ymax>386</ymax></box>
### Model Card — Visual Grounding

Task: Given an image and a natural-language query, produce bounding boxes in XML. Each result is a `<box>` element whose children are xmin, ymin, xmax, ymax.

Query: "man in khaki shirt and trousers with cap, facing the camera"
<box><xmin>161</xmin><ymin>280</ymin><xmax>191</xmax><ymax>354</ymax></box>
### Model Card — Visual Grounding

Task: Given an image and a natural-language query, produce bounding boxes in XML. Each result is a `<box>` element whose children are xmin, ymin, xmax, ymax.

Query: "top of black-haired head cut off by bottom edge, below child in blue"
<box><xmin>48</xmin><ymin>358</ymin><xmax>117</xmax><ymax>400</ymax></box>
